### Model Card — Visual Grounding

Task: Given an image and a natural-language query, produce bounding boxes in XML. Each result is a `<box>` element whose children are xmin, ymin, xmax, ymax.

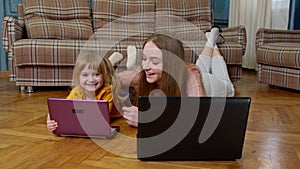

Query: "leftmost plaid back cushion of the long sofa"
<box><xmin>23</xmin><ymin>0</ymin><xmax>93</xmax><ymax>39</ymax></box>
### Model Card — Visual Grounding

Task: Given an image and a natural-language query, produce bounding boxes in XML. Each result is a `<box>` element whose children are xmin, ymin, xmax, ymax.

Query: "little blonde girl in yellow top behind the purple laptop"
<box><xmin>47</xmin><ymin>52</ymin><xmax>122</xmax><ymax>131</ymax></box>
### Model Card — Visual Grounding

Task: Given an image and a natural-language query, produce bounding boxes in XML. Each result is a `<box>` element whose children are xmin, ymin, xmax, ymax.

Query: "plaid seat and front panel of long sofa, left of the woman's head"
<box><xmin>14</xmin><ymin>39</ymin><xmax>143</xmax><ymax>86</ymax></box>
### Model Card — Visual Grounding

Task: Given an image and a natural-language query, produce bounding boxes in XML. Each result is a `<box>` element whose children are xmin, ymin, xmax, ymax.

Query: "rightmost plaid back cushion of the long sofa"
<box><xmin>155</xmin><ymin>0</ymin><xmax>212</xmax><ymax>40</ymax></box>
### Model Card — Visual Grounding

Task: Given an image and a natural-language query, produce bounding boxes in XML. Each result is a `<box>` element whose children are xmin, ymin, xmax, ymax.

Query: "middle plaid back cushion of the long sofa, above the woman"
<box><xmin>93</xmin><ymin>0</ymin><xmax>155</xmax><ymax>41</ymax></box>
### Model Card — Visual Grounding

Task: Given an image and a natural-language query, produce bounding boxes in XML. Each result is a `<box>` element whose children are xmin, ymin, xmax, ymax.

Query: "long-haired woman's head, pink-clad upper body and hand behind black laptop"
<box><xmin>117</xmin><ymin>34</ymin><xmax>204</xmax><ymax>127</ymax></box>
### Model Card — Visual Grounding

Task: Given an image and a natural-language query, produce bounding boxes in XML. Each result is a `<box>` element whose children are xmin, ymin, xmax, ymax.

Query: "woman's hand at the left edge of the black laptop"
<box><xmin>122</xmin><ymin>106</ymin><xmax>138</xmax><ymax>127</ymax></box>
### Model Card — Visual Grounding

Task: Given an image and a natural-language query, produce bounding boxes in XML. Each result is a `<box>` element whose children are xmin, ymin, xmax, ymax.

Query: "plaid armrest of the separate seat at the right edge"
<box><xmin>255</xmin><ymin>28</ymin><xmax>300</xmax><ymax>48</ymax></box>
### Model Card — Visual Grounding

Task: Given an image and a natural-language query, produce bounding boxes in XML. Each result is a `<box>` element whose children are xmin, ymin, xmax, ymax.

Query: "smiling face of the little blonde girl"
<box><xmin>79</xmin><ymin>65</ymin><xmax>103</xmax><ymax>93</ymax></box>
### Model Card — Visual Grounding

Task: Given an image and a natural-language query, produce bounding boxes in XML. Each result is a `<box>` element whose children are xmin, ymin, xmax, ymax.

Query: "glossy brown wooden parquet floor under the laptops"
<box><xmin>0</xmin><ymin>70</ymin><xmax>300</xmax><ymax>169</ymax></box>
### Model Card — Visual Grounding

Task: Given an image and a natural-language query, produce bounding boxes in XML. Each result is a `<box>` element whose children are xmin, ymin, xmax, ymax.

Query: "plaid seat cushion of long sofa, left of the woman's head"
<box><xmin>14</xmin><ymin>39</ymin><xmax>138</xmax><ymax>67</ymax></box>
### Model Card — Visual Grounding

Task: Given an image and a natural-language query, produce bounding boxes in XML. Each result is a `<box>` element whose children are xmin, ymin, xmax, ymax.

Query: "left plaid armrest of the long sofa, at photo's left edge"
<box><xmin>2</xmin><ymin>16</ymin><xmax>26</xmax><ymax>52</ymax></box>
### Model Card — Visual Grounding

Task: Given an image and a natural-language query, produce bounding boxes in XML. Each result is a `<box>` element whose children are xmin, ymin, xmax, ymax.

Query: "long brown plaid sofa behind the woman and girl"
<box><xmin>2</xmin><ymin>0</ymin><xmax>246</xmax><ymax>91</ymax></box>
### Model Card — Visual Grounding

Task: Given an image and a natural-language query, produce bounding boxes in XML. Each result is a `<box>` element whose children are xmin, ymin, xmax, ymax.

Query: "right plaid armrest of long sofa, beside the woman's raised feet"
<box><xmin>222</xmin><ymin>25</ymin><xmax>247</xmax><ymax>54</ymax></box>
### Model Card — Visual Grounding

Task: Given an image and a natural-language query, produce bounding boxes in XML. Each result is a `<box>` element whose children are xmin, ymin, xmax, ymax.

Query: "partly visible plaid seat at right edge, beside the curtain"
<box><xmin>256</xmin><ymin>28</ymin><xmax>300</xmax><ymax>90</ymax></box>
